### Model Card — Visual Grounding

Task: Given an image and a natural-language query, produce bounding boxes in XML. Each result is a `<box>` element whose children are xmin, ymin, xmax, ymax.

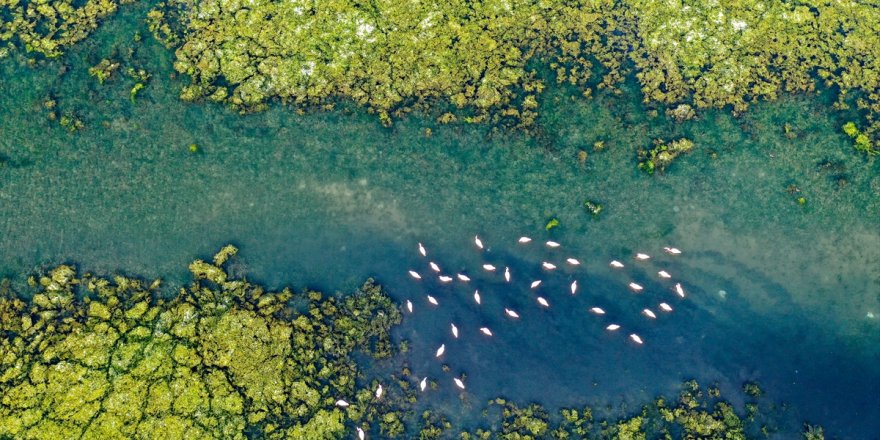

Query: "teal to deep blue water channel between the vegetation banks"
<box><xmin>0</xmin><ymin>6</ymin><xmax>880</xmax><ymax>438</ymax></box>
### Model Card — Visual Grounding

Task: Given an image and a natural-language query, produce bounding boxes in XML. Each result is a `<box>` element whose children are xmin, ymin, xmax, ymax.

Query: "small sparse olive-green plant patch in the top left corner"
<box><xmin>0</xmin><ymin>0</ymin><xmax>134</xmax><ymax>58</ymax></box>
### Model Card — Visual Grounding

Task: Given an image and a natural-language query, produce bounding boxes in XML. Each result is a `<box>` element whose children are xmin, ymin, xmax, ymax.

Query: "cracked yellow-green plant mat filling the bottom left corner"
<box><xmin>0</xmin><ymin>246</ymin><xmax>401</xmax><ymax>439</ymax></box>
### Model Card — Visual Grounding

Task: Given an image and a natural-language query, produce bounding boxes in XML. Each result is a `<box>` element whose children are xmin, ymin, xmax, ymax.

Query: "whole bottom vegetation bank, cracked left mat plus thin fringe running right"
<box><xmin>0</xmin><ymin>246</ymin><xmax>824</xmax><ymax>439</ymax></box>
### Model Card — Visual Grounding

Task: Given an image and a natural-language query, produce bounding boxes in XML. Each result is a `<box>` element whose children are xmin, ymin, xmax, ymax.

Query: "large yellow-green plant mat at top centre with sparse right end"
<box><xmin>151</xmin><ymin>0</ymin><xmax>620</xmax><ymax>125</ymax></box>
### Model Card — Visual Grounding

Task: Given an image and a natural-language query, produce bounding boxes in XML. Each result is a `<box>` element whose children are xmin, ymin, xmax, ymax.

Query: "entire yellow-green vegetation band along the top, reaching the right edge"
<box><xmin>141</xmin><ymin>0</ymin><xmax>880</xmax><ymax>152</ymax></box>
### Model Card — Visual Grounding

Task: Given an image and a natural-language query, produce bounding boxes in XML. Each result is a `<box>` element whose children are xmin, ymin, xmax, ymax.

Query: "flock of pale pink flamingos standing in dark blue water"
<box><xmin>336</xmin><ymin>236</ymin><xmax>685</xmax><ymax>440</ymax></box>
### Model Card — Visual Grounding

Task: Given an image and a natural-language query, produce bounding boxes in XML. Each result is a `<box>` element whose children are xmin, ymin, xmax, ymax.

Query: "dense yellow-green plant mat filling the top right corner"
<box><xmin>629</xmin><ymin>0</ymin><xmax>880</xmax><ymax>156</ymax></box>
